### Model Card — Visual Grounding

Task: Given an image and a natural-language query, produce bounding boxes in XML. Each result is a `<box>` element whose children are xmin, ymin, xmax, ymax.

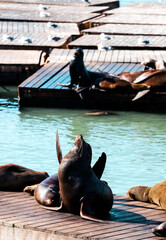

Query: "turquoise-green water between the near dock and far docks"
<box><xmin>0</xmin><ymin>88</ymin><xmax>166</xmax><ymax>195</ymax></box>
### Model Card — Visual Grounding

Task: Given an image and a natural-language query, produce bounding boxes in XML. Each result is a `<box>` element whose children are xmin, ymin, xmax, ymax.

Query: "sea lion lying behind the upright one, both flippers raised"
<box><xmin>24</xmin><ymin>133</ymin><xmax>106</xmax><ymax>210</ymax></box>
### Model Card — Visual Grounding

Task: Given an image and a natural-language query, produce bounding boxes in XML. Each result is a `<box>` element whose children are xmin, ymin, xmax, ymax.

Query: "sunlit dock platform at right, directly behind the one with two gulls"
<box><xmin>81</xmin><ymin>24</ymin><xmax>166</xmax><ymax>36</ymax></box>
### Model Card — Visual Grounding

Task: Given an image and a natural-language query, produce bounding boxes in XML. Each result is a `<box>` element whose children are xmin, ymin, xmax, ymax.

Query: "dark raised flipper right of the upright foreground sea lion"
<box><xmin>92</xmin><ymin>152</ymin><xmax>106</xmax><ymax>179</ymax></box>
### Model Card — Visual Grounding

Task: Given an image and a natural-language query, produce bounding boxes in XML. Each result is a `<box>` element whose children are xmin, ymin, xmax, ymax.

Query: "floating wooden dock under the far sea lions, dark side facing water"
<box><xmin>18</xmin><ymin>49</ymin><xmax>166</xmax><ymax>111</ymax></box>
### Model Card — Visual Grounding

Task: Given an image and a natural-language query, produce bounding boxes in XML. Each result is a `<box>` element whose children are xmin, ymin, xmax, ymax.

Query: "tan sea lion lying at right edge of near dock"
<box><xmin>126</xmin><ymin>181</ymin><xmax>166</xmax><ymax>210</ymax></box>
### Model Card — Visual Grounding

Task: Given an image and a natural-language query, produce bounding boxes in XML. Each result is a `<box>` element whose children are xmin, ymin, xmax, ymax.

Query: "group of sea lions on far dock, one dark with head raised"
<box><xmin>61</xmin><ymin>48</ymin><xmax>166</xmax><ymax>100</ymax></box>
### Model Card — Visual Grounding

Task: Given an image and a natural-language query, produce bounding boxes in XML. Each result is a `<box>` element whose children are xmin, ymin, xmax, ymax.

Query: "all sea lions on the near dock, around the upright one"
<box><xmin>0</xmin><ymin>132</ymin><xmax>166</xmax><ymax>236</ymax></box>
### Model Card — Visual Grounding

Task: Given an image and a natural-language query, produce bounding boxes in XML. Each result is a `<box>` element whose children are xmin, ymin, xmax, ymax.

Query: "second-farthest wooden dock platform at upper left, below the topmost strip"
<box><xmin>0</xmin><ymin>2</ymin><xmax>108</xmax><ymax>14</ymax></box>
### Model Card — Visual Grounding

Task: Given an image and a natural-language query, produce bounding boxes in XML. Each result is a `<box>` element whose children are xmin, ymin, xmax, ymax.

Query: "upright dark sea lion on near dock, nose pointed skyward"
<box><xmin>42</xmin><ymin>132</ymin><xmax>113</xmax><ymax>221</ymax></box>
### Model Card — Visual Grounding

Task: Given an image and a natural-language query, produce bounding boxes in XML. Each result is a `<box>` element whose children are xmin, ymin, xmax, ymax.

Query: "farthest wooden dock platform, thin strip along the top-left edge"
<box><xmin>0</xmin><ymin>0</ymin><xmax>119</xmax><ymax>8</ymax></box>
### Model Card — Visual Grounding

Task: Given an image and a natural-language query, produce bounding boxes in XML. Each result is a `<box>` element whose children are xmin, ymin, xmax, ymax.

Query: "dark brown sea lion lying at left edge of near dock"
<box><xmin>0</xmin><ymin>164</ymin><xmax>48</xmax><ymax>191</ymax></box>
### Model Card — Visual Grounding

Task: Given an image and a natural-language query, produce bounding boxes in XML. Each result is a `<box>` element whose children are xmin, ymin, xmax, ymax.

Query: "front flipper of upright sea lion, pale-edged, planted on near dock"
<box><xmin>80</xmin><ymin>197</ymin><xmax>105</xmax><ymax>222</ymax></box>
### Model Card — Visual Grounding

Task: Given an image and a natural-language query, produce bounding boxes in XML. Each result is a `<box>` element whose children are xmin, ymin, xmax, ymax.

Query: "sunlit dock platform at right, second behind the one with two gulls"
<box><xmin>91</xmin><ymin>13</ymin><xmax>166</xmax><ymax>26</ymax></box>
